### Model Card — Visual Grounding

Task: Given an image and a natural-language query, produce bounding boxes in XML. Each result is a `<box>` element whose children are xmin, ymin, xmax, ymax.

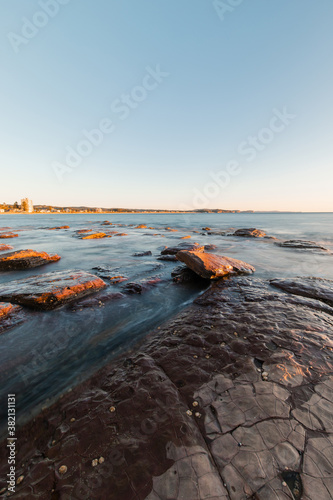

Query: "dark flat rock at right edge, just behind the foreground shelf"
<box><xmin>270</xmin><ymin>278</ymin><xmax>333</xmax><ymax>307</ymax></box>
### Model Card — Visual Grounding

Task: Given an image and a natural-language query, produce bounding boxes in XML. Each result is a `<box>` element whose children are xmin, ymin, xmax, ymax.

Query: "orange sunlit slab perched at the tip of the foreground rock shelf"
<box><xmin>176</xmin><ymin>250</ymin><xmax>255</xmax><ymax>279</ymax></box>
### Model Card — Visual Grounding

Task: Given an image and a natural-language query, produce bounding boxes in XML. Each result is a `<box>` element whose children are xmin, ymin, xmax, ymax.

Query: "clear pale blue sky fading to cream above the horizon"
<box><xmin>0</xmin><ymin>0</ymin><xmax>333</xmax><ymax>212</ymax></box>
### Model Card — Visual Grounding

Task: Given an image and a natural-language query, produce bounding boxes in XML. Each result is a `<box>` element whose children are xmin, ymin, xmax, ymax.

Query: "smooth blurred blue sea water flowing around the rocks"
<box><xmin>0</xmin><ymin>214</ymin><xmax>333</xmax><ymax>434</ymax></box>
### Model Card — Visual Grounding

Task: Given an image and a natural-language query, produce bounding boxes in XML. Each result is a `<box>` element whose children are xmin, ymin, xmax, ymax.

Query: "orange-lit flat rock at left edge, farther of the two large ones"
<box><xmin>0</xmin><ymin>250</ymin><xmax>61</xmax><ymax>271</ymax></box>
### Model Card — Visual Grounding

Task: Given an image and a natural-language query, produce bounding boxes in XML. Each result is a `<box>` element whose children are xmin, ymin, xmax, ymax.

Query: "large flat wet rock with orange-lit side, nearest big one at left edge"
<box><xmin>0</xmin><ymin>271</ymin><xmax>106</xmax><ymax>310</ymax></box>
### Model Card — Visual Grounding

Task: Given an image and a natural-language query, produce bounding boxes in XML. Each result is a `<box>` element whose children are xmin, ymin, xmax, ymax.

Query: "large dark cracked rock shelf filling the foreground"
<box><xmin>0</xmin><ymin>277</ymin><xmax>333</xmax><ymax>500</ymax></box>
